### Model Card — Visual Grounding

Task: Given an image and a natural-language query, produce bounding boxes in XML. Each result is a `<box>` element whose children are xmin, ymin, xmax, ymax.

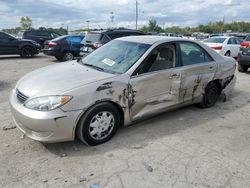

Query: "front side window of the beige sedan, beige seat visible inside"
<box><xmin>136</xmin><ymin>44</ymin><xmax>176</xmax><ymax>74</ymax></box>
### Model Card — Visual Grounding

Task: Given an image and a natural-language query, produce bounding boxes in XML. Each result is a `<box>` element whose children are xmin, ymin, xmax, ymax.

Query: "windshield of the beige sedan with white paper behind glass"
<box><xmin>80</xmin><ymin>40</ymin><xmax>150</xmax><ymax>74</ymax></box>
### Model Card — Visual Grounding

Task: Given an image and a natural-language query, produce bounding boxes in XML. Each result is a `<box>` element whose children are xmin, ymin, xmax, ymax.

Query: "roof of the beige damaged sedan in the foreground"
<box><xmin>115</xmin><ymin>35</ymin><xmax>190</xmax><ymax>45</ymax></box>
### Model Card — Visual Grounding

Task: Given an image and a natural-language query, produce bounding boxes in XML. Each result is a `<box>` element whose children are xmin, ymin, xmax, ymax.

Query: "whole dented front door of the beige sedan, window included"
<box><xmin>129</xmin><ymin>44</ymin><xmax>181</xmax><ymax>121</ymax></box>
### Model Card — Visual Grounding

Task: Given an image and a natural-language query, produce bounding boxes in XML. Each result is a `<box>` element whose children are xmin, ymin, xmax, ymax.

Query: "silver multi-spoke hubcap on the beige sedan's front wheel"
<box><xmin>89</xmin><ymin>111</ymin><xmax>115</xmax><ymax>140</ymax></box>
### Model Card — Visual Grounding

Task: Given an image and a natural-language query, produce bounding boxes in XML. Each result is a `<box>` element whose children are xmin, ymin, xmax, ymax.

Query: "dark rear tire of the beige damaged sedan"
<box><xmin>199</xmin><ymin>82</ymin><xmax>219</xmax><ymax>108</ymax></box>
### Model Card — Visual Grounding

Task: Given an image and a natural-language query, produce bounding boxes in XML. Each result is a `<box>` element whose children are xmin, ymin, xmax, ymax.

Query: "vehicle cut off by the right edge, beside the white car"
<box><xmin>238</xmin><ymin>45</ymin><xmax>250</xmax><ymax>72</ymax></box>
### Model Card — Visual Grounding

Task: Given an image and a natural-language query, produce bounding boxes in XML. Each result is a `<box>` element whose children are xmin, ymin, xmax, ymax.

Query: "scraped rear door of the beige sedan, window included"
<box><xmin>179</xmin><ymin>42</ymin><xmax>217</xmax><ymax>102</ymax></box>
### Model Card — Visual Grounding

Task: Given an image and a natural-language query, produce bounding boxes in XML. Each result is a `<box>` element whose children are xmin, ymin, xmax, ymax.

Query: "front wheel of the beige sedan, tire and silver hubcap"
<box><xmin>76</xmin><ymin>102</ymin><xmax>121</xmax><ymax>146</ymax></box>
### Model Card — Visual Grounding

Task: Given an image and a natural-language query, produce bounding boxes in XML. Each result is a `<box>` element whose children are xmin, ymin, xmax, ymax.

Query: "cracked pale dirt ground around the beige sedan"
<box><xmin>0</xmin><ymin>54</ymin><xmax>250</xmax><ymax>188</ymax></box>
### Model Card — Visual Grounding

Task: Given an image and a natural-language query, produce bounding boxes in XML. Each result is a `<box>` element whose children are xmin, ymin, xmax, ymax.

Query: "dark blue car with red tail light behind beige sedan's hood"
<box><xmin>43</xmin><ymin>35</ymin><xmax>84</xmax><ymax>61</ymax></box>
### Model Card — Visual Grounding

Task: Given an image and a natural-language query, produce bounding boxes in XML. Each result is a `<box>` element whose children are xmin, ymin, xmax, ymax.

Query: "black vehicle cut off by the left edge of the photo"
<box><xmin>0</xmin><ymin>32</ymin><xmax>41</xmax><ymax>57</ymax></box>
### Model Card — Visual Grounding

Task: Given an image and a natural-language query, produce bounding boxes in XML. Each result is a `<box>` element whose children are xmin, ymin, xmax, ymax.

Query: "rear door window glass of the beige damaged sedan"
<box><xmin>180</xmin><ymin>42</ymin><xmax>213</xmax><ymax>66</ymax></box>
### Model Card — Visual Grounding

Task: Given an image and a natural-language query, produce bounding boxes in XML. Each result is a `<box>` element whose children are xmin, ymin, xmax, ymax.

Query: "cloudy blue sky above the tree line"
<box><xmin>0</xmin><ymin>0</ymin><xmax>250</xmax><ymax>30</ymax></box>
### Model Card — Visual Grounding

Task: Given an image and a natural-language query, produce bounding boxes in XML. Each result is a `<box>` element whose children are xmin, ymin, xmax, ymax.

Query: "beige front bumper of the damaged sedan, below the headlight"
<box><xmin>10</xmin><ymin>91</ymin><xmax>82</xmax><ymax>143</ymax></box>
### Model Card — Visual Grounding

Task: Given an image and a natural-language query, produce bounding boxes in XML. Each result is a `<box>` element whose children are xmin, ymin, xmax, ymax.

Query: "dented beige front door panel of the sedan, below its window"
<box><xmin>129</xmin><ymin>68</ymin><xmax>181</xmax><ymax>120</ymax></box>
